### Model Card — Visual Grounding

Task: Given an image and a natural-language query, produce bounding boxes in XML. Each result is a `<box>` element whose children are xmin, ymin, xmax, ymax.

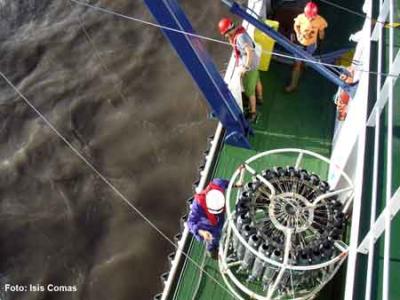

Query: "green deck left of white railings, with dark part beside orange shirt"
<box><xmin>169</xmin><ymin>0</ymin><xmax>363</xmax><ymax>300</ymax></box>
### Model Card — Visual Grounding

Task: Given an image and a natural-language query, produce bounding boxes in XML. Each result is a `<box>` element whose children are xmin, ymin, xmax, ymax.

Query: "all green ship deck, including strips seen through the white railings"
<box><xmin>161</xmin><ymin>0</ymin><xmax>400</xmax><ymax>300</ymax></box>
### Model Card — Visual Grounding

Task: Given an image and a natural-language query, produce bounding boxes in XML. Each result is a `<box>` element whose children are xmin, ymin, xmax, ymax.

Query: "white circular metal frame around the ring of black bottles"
<box><xmin>219</xmin><ymin>148</ymin><xmax>353</xmax><ymax>300</ymax></box>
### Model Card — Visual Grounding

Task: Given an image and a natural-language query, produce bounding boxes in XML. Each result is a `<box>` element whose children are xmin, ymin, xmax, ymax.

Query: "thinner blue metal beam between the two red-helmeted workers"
<box><xmin>222</xmin><ymin>0</ymin><xmax>356</xmax><ymax>96</ymax></box>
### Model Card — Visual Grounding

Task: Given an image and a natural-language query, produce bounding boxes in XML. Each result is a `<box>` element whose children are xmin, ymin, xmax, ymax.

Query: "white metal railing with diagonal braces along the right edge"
<box><xmin>342</xmin><ymin>0</ymin><xmax>400</xmax><ymax>300</ymax></box>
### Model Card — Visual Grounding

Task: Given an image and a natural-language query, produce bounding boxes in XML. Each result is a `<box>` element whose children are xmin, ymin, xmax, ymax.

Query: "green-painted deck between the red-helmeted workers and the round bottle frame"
<box><xmin>171</xmin><ymin>59</ymin><xmax>335</xmax><ymax>300</ymax></box>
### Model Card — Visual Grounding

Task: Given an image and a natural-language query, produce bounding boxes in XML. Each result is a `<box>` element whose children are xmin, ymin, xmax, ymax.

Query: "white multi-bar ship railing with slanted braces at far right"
<box><xmin>345</xmin><ymin>0</ymin><xmax>400</xmax><ymax>300</ymax></box>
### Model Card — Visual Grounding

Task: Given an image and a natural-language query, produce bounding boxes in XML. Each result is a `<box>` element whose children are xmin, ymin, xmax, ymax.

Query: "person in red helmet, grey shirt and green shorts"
<box><xmin>218</xmin><ymin>18</ymin><xmax>262</xmax><ymax>122</ymax></box>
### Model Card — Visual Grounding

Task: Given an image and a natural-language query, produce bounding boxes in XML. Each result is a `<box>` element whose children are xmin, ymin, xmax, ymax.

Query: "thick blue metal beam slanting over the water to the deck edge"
<box><xmin>144</xmin><ymin>0</ymin><xmax>251</xmax><ymax>148</ymax></box>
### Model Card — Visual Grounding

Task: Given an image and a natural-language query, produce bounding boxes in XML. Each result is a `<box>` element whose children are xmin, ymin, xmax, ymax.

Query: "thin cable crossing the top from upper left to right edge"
<box><xmin>69</xmin><ymin>0</ymin><xmax>398</xmax><ymax>78</ymax></box>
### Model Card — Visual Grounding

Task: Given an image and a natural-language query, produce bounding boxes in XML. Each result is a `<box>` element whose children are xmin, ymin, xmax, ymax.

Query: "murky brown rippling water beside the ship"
<box><xmin>0</xmin><ymin>0</ymin><xmax>230</xmax><ymax>300</ymax></box>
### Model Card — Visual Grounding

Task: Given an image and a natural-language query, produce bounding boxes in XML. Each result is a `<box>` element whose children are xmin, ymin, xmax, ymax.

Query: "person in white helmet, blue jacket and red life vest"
<box><xmin>187</xmin><ymin>178</ymin><xmax>241</xmax><ymax>259</ymax></box>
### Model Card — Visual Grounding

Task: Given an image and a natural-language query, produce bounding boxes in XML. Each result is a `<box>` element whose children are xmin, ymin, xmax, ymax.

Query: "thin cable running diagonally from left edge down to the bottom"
<box><xmin>0</xmin><ymin>71</ymin><xmax>239</xmax><ymax>298</ymax></box>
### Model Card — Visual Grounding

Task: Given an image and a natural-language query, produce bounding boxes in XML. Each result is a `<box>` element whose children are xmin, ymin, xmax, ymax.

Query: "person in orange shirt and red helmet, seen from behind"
<box><xmin>285</xmin><ymin>2</ymin><xmax>328</xmax><ymax>92</ymax></box>
